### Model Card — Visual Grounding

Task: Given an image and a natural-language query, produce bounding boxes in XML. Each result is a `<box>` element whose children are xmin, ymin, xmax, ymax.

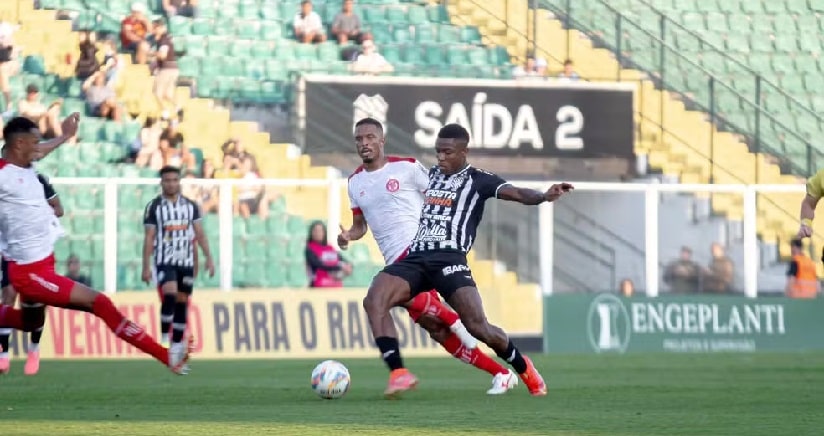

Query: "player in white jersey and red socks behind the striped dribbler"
<box><xmin>338</xmin><ymin>118</ymin><xmax>518</xmax><ymax>395</ymax></box>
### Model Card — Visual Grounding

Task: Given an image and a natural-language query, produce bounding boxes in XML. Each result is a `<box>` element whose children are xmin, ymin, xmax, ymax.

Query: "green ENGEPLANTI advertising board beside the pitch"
<box><xmin>544</xmin><ymin>294</ymin><xmax>824</xmax><ymax>353</ymax></box>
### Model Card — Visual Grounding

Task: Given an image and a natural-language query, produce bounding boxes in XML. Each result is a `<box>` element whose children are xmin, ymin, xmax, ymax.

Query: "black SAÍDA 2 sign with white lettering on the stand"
<box><xmin>298</xmin><ymin>76</ymin><xmax>634</xmax><ymax>158</ymax></box>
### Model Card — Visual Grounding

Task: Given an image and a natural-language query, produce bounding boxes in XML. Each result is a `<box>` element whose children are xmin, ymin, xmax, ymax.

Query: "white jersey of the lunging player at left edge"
<box><xmin>0</xmin><ymin>159</ymin><xmax>60</xmax><ymax>265</ymax></box>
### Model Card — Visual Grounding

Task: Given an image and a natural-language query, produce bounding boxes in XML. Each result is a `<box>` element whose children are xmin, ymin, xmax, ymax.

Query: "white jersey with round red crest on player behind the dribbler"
<box><xmin>348</xmin><ymin>156</ymin><xmax>429</xmax><ymax>263</ymax></box>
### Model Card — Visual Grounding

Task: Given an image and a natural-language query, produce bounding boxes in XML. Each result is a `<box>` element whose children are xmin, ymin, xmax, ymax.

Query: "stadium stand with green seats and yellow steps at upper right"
<box><xmin>449</xmin><ymin>0</ymin><xmax>824</xmax><ymax>274</ymax></box>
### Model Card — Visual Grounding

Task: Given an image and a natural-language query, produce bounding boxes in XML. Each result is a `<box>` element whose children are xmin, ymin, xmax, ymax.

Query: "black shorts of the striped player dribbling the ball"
<box><xmin>383</xmin><ymin>250</ymin><xmax>477</xmax><ymax>300</ymax></box>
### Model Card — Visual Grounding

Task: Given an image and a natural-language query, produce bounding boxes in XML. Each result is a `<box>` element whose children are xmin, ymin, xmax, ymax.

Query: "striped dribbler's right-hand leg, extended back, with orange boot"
<box><xmin>447</xmin><ymin>286</ymin><xmax>547</xmax><ymax>396</ymax></box>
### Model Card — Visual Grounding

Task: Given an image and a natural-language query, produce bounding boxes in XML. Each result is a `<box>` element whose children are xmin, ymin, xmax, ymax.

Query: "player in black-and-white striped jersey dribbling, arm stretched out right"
<box><xmin>363</xmin><ymin>124</ymin><xmax>573</xmax><ymax>397</ymax></box>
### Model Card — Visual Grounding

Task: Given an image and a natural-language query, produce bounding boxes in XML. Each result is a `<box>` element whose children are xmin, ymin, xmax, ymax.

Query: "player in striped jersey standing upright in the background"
<box><xmin>142</xmin><ymin>166</ymin><xmax>215</xmax><ymax>370</ymax></box>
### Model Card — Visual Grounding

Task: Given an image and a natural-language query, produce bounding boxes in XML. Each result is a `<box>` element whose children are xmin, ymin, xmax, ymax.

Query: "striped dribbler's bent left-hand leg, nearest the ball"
<box><xmin>363</xmin><ymin>272</ymin><xmax>418</xmax><ymax>398</ymax></box>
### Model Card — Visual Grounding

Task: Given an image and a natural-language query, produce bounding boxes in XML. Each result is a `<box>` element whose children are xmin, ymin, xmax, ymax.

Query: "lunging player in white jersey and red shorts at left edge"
<box><xmin>0</xmin><ymin>113</ymin><xmax>189</xmax><ymax>374</ymax></box>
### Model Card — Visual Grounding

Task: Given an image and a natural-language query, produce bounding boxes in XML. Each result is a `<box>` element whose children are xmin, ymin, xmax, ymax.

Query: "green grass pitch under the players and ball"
<box><xmin>0</xmin><ymin>353</ymin><xmax>824</xmax><ymax>436</ymax></box>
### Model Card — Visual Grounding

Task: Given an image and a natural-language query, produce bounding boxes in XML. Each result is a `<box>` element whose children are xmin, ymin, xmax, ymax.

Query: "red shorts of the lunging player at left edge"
<box><xmin>9</xmin><ymin>254</ymin><xmax>75</xmax><ymax>307</ymax></box>
